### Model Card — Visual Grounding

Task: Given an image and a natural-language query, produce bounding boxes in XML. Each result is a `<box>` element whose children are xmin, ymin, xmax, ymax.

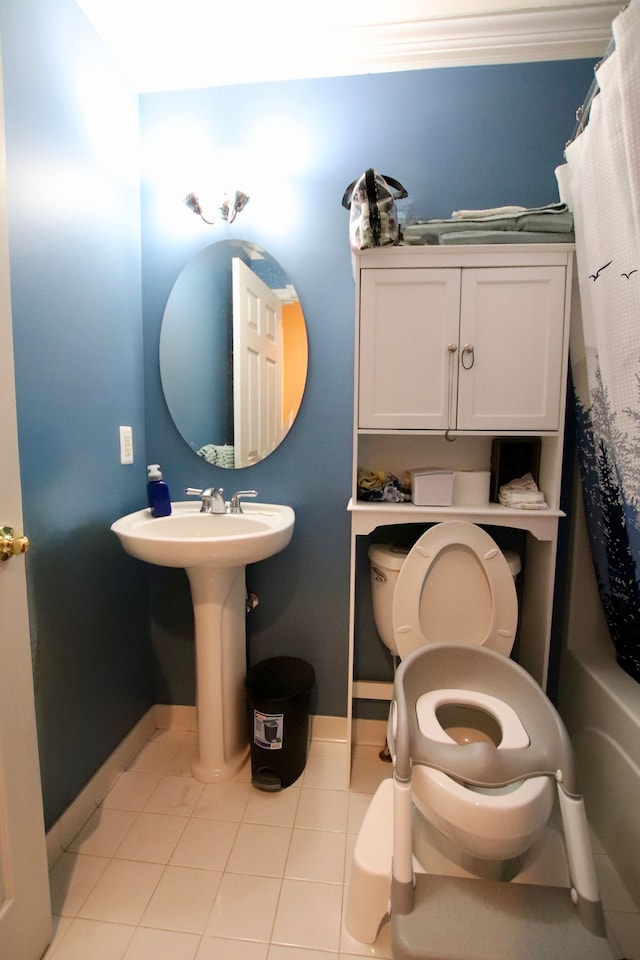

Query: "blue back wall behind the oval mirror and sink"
<box><xmin>141</xmin><ymin>61</ymin><xmax>593</xmax><ymax>716</ymax></box>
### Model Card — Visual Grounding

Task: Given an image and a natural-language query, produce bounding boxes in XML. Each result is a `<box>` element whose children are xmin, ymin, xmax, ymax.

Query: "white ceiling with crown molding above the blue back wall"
<box><xmin>77</xmin><ymin>0</ymin><xmax>623</xmax><ymax>92</ymax></box>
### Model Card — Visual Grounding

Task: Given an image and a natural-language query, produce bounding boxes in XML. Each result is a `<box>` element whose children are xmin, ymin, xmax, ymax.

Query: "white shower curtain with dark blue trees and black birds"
<box><xmin>556</xmin><ymin>0</ymin><xmax>640</xmax><ymax>682</ymax></box>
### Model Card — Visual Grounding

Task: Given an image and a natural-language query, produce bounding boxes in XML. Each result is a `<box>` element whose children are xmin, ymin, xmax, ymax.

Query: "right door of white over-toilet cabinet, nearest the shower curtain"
<box><xmin>457</xmin><ymin>267</ymin><xmax>565</xmax><ymax>432</ymax></box>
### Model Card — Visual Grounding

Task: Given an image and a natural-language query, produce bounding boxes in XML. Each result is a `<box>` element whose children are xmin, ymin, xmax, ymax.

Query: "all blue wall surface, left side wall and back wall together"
<box><xmin>0</xmin><ymin>0</ymin><xmax>592</xmax><ymax>824</ymax></box>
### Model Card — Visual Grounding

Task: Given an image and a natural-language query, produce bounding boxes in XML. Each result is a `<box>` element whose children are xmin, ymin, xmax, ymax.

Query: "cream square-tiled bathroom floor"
<box><xmin>45</xmin><ymin>731</ymin><xmax>640</xmax><ymax>960</ymax></box>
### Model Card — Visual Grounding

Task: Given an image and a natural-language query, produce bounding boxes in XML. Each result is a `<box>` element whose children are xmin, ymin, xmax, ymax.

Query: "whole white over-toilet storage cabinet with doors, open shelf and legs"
<box><xmin>348</xmin><ymin>244</ymin><xmax>574</xmax><ymax>780</ymax></box>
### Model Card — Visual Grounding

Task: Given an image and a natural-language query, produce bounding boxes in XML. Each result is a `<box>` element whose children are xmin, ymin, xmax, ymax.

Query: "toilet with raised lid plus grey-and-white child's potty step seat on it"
<box><xmin>345</xmin><ymin>521</ymin><xmax>605</xmax><ymax>957</ymax></box>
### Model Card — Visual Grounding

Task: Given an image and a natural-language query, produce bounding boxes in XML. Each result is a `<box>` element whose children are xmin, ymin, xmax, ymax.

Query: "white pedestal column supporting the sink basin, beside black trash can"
<box><xmin>187</xmin><ymin>566</ymin><xmax>249</xmax><ymax>783</ymax></box>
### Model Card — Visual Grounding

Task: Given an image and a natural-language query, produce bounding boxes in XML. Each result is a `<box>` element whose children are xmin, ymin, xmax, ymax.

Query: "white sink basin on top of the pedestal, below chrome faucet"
<box><xmin>111</xmin><ymin>501</ymin><xmax>295</xmax><ymax>569</ymax></box>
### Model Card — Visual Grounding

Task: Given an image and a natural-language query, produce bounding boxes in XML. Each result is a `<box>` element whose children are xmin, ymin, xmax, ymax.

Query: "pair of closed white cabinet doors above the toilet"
<box><xmin>358</xmin><ymin>266</ymin><xmax>565</xmax><ymax>433</ymax></box>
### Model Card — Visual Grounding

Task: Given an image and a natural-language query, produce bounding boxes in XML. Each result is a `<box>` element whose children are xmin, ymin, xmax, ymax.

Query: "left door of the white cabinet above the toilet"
<box><xmin>358</xmin><ymin>269</ymin><xmax>460</xmax><ymax>430</ymax></box>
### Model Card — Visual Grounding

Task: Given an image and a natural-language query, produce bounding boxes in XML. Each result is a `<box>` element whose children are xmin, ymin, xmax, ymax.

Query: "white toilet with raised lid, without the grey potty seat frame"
<box><xmin>369</xmin><ymin>521</ymin><xmax>553</xmax><ymax>860</ymax></box>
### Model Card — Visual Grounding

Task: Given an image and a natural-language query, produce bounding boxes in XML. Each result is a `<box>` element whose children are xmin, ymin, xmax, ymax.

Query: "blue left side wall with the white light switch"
<box><xmin>0</xmin><ymin>0</ymin><xmax>153</xmax><ymax>825</ymax></box>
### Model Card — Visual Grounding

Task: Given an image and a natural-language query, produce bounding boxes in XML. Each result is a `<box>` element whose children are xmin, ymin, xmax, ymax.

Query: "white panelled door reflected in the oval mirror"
<box><xmin>232</xmin><ymin>257</ymin><xmax>283</xmax><ymax>467</ymax></box>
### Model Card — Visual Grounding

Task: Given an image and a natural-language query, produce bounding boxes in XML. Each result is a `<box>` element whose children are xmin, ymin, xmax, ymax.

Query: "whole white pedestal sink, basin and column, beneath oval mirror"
<box><xmin>111</xmin><ymin>501</ymin><xmax>295</xmax><ymax>783</ymax></box>
